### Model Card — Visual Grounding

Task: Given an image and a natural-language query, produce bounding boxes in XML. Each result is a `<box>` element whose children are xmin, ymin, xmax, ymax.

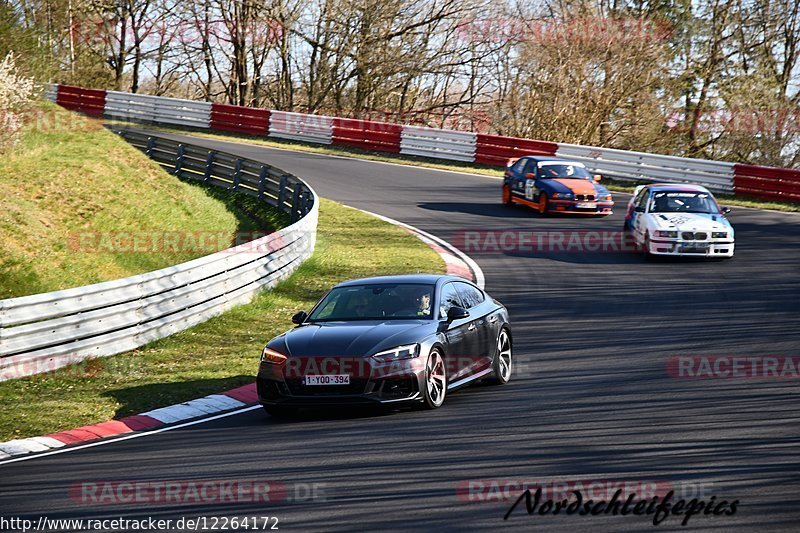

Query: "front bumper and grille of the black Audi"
<box><xmin>256</xmin><ymin>358</ymin><xmax>424</xmax><ymax>407</ymax></box>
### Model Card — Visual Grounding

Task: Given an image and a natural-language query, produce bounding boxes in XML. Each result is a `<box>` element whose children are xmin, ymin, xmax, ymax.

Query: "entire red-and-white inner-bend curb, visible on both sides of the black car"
<box><xmin>0</xmin><ymin>210</ymin><xmax>486</xmax><ymax>462</ymax></box>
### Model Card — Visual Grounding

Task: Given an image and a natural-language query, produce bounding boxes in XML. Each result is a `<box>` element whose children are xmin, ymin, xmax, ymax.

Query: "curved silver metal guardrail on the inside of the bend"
<box><xmin>0</xmin><ymin>132</ymin><xmax>319</xmax><ymax>381</ymax></box>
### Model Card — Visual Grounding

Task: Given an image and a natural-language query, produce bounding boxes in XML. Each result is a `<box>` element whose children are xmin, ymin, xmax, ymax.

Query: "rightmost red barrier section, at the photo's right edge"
<box><xmin>733</xmin><ymin>165</ymin><xmax>800</xmax><ymax>203</ymax></box>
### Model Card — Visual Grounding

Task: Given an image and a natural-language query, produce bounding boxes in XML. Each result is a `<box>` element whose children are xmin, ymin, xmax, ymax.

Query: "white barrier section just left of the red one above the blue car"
<box><xmin>400</xmin><ymin>126</ymin><xmax>476</xmax><ymax>162</ymax></box>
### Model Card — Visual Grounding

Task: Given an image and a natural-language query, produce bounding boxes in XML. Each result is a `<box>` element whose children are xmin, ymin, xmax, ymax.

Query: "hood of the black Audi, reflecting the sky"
<box><xmin>270</xmin><ymin>320</ymin><xmax>437</xmax><ymax>356</ymax></box>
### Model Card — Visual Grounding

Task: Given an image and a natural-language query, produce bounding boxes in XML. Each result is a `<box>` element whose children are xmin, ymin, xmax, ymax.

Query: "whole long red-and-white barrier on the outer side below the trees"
<box><xmin>45</xmin><ymin>85</ymin><xmax>800</xmax><ymax>202</ymax></box>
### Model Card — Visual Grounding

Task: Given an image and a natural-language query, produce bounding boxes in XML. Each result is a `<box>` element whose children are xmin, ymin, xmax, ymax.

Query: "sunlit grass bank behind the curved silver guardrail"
<box><xmin>0</xmin><ymin>102</ymin><xmax>283</xmax><ymax>299</ymax></box>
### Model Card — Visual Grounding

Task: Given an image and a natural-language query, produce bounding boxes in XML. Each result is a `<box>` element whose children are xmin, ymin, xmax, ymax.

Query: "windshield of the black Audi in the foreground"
<box><xmin>308</xmin><ymin>283</ymin><xmax>434</xmax><ymax>322</ymax></box>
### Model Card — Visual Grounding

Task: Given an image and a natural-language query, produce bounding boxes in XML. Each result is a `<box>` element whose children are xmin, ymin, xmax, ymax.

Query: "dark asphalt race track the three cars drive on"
<box><xmin>0</xmin><ymin>130</ymin><xmax>800</xmax><ymax>531</ymax></box>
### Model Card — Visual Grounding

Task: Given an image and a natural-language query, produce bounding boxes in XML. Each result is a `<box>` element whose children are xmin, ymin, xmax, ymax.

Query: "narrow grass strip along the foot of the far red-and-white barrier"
<box><xmin>117</xmin><ymin>119</ymin><xmax>800</xmax><ymax>213</ymax></box>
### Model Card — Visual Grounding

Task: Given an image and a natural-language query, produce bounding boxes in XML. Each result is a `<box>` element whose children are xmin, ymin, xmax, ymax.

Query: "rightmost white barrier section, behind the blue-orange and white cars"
<box><xmin>556</xmin><ymin>143</ymin><xmax>733</xmax><ymax>194</ymax></box>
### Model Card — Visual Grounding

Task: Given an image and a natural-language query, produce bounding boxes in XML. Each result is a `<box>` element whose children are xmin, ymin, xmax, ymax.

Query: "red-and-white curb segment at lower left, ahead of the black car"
<box><xmin>0</xmin><ymin>383</ymin><xmax>258</xmax><ymax>460</ymax></box>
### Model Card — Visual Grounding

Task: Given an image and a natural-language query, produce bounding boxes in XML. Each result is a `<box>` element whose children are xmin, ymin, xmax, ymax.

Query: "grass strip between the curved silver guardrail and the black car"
<box><xmin>0</xmin><ymin>200</ymin><xmax>445</xmax><ymax>441</ymax></box>
